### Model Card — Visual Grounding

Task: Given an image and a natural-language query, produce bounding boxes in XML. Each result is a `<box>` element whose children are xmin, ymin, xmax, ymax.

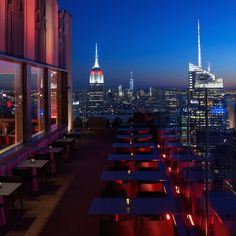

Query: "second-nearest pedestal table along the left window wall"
<box><xmin>16</xmin><ymin>160</ymin><xmax>49</xmax><ymax>192</ymax></box>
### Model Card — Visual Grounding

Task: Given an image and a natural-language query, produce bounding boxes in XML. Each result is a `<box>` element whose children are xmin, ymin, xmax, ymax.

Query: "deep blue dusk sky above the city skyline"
<box><xmin>59</xmin><ymin>0</ymin><xmax>236</xmax><ymax>89</ymax></box>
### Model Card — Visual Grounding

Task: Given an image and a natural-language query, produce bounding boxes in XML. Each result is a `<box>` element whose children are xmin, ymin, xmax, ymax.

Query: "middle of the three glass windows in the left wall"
<box><xmin>31</xmin><ymin>67</ymin><xmax>45</xmax><ymax>135</ymax></box>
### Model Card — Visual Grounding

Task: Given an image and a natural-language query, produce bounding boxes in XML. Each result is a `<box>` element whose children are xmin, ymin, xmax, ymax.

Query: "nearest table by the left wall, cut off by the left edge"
<box><xmin>0</xmin><ymin>182</ymin><xmax>23</xmax><ymax>227</ymax></box>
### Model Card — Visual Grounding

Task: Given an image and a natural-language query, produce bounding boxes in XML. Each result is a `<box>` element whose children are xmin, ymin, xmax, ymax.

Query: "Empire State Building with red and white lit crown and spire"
<box><xmin>88</xmin><ymin>44</ymin><xmax>104</xmax><ymax>115</ymax></box>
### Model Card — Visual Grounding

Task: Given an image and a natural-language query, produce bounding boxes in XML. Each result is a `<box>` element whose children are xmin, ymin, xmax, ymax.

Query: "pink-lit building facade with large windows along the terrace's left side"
<box><xmin>0</xmin><ymin>0</ymin><xmax>72</xmax><ymax>164</ymax></box>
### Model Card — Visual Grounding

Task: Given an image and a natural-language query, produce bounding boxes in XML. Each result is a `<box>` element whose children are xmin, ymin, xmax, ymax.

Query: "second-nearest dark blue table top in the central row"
<box><xmin>101</xmin><ymin>171</ymin><xmax>166</xmax><ymax>181</ymax></box>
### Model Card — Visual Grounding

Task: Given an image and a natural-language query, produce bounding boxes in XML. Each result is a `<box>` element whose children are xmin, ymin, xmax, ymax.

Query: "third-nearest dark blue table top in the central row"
<box><xmin>108</xmin><ymin>153</ymin><xmax>160</xmax><ymax>161</ymax></box>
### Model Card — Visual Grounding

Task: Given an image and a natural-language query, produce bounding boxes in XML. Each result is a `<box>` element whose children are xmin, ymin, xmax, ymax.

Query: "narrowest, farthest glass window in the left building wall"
<box><xmin>49</xmin><ymin>70</ymin><xmax>60</xmax><ymax>127</ymax></box>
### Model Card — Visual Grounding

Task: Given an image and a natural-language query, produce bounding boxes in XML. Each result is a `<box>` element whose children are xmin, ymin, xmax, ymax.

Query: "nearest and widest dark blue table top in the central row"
<box><xmin>89</xmin><ymin>197</ymin><xmax>177</xmax><ymax>215</ymax></box>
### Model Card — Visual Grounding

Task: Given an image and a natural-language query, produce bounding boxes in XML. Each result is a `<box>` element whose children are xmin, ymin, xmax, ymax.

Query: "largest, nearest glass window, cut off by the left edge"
<box><xmin>0</xmin><ymin>60</ymin><xmax>23</xmax><ymax>153</ymax></box>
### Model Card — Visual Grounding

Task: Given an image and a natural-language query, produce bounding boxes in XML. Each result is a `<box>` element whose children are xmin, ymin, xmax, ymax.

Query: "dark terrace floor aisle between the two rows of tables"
<box><xmin>7</xmin><ymin>129</ymin><xmax>116</xmax><ymax>236</ymax></box>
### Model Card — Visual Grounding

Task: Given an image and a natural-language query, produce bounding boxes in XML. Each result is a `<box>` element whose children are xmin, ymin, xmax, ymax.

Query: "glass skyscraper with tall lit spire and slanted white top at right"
<box><xmin>189</xmin><ymin>21</ymin><xmax>226</xmax><ymax>155</ymax></box>
